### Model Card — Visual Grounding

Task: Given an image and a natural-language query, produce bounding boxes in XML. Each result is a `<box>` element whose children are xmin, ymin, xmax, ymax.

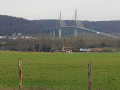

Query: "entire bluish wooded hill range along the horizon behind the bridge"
<box><xmin>0</xmin><ymin>15</ymin><xmax>120</xmax><ymax>36</ymax></box>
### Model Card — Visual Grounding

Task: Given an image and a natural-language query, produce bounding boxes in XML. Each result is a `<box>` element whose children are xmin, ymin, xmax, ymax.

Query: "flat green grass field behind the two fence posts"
<box><xmin>0</xmin><ymin>51</ymin><xmax>120</xmax><ymax>90</ymax></box>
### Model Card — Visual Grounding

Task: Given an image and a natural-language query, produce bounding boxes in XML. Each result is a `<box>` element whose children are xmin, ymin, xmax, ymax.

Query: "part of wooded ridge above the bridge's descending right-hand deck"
<box><xmin>82</xmin><ymin>20</ymin><xmax>120</xmax><ymax>34</ymax></box>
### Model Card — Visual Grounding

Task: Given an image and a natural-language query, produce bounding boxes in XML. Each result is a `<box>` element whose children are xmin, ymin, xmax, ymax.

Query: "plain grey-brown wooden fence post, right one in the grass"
<box><xmin>88</xmin><ymin>62</ymin><xmax>93</xmax><ymax>90</ymax></box>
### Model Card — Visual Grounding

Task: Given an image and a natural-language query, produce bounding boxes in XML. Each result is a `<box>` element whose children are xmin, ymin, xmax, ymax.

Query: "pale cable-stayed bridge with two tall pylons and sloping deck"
<box><xmin>49</xmin><ymin>10</ymin><xmax>120</xmax><ymax>38</ymax></box>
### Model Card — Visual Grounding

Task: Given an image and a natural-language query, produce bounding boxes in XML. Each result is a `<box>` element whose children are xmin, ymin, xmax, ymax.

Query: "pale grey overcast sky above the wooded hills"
<box><xmin>0</xmin><ymin>0</ymin><xmax>120</xmax><ymax>20</ymax></box>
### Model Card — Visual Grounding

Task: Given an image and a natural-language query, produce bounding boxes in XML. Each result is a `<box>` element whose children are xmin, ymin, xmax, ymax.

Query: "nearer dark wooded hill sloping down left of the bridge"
<box><xmin>0</xmin><ymin>15</ymin><xmax>45</xmax><ymax>35</ymax></box>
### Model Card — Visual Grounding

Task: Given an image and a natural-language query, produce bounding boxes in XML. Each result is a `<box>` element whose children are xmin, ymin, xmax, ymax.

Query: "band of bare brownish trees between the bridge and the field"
<box><xmin>3</xmin><ymin>34</ymin><xmax>120</xmax><ymax>52</ymax></box>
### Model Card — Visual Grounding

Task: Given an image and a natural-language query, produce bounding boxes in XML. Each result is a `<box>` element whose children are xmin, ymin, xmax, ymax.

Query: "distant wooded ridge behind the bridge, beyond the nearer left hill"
<box><xmin>35</xmin><ymin>20</ymin><xmax>120</xmax><ymax>34</ymax></box>
